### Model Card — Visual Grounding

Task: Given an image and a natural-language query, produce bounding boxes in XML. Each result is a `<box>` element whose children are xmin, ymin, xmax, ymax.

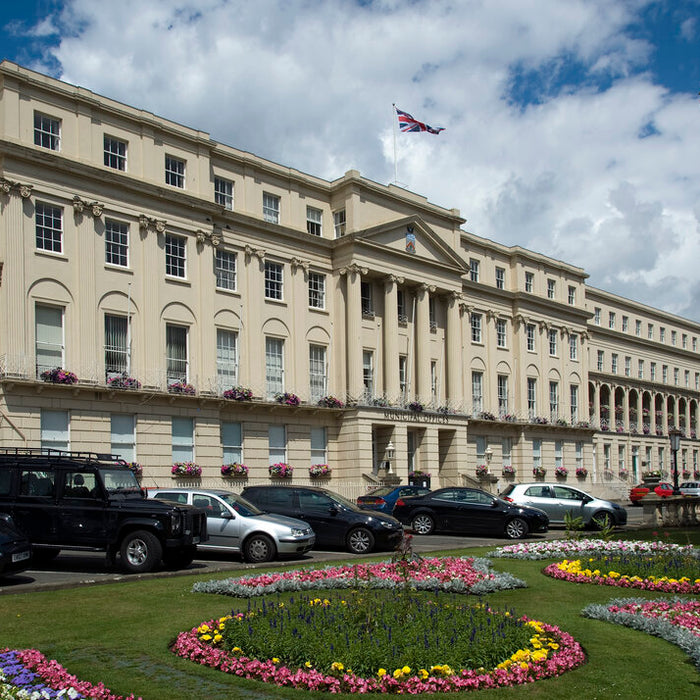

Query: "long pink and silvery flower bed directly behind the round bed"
<box><xmin>192</xmin><ymin>557</ymin><xmax>526</xmax><ymax>598</ymax></box>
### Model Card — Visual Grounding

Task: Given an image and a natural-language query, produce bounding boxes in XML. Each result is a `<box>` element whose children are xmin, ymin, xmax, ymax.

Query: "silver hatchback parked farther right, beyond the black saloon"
<box><xmin>500</xmin><ymin>481</ymin><xmax>627</xmax><ymax>527</ymax></box>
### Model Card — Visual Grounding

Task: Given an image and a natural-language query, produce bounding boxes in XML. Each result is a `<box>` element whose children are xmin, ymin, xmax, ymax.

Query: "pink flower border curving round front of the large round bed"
<box><xmin>170</xmin><ymin>617</ymin><xmax>586</xmax><ymax>695</ymax></box>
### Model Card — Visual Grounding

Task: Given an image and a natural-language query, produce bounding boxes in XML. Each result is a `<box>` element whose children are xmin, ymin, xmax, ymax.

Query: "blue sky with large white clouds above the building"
<box><xmin>0</xmin><ymin>0</ymin><xmax>700</xmax><ymax>321</ymax></box>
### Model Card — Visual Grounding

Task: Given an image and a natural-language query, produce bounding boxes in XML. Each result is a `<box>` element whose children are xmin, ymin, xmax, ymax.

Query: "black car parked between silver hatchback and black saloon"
<box><xmin>241</xmin><ymin>486</ymin><xmax>403</xmax><ymax>554</ymax></box>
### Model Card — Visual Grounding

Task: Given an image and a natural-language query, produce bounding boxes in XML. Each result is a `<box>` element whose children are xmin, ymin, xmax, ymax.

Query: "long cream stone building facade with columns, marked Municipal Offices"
<box><xmin>0</xmin><ymin>61</ymin><xmax>700</xmax><ymax>496</ymax></box>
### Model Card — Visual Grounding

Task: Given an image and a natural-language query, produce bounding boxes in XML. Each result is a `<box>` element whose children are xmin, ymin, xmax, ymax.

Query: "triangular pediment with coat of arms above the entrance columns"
<box><xmin>345</xmin><ymin>216</ymin><xmax>467</xmax><ymax>272</ymax></box>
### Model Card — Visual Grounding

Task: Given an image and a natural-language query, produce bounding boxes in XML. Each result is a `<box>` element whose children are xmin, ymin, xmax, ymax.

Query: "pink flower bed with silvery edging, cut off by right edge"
<box><xmin>582</xmin><ymin>598</ymin><xmax>700</xmax><ymax>670</ymax></box>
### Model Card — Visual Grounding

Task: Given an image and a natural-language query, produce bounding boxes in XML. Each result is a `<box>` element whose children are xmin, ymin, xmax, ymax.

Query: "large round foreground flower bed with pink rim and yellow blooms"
<box><xmin>172</xmin><ymin>598</ymin><xmax>585</xmax><ymax>694</ymax></box>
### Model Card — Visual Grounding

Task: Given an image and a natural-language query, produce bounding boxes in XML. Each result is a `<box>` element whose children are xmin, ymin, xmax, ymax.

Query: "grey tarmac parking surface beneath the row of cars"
<box><xmin>0</xmin><ymin>508</ymin><xmax>642</xmax><ymax>595</ymax></box>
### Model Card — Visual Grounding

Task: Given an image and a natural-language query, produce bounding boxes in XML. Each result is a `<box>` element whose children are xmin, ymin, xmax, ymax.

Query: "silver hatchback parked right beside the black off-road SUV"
<box><xmin>147</xmin><ymin>488</ymin><xmax>316</xmax><ymax>563</ymax></box>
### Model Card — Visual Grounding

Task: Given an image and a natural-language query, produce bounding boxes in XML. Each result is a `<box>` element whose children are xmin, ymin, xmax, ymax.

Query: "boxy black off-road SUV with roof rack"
<box><xmin>0</xmin><ymin>448</ymin><xmax>207</xmax><ymax>573</ymax></box>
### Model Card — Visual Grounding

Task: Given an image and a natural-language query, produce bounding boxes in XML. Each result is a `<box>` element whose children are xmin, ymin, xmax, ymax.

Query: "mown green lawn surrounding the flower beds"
<box><xmin>0</xmin><ymin>529</ymin><xmax>700</xmax><ymax>700</ymax></box>
